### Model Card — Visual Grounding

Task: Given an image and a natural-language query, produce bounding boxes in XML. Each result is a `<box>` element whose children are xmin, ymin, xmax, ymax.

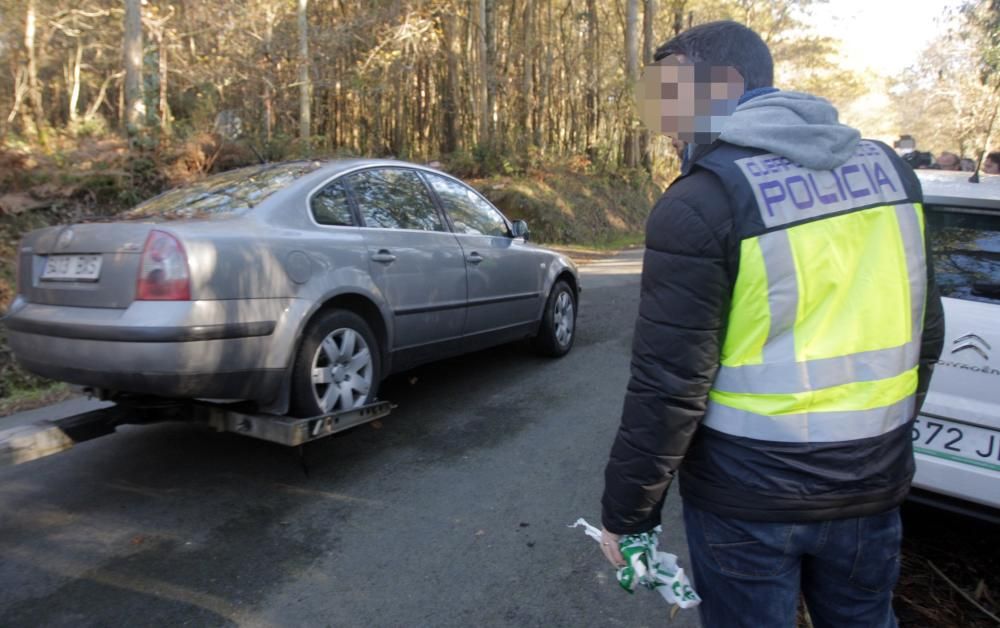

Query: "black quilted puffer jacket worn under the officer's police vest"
<box><xmin>602</xmin><ymin>145</ymin><xmax>944</xmax><ymax>534</ymax></box>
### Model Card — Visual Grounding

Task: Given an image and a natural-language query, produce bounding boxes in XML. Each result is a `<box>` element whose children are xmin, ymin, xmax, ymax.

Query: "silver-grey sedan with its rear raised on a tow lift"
<box><xmin>3</xmin><ymin>160</ymin><xmax>580</xmax><ymax>416</ymax></box>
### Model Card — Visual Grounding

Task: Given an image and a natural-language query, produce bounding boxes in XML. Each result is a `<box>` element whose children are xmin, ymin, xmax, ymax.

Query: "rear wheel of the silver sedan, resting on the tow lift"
<box><xmin>291</xmin><ymin>310</ymin><xmax>382</xmax><ymax>417</ymax></box>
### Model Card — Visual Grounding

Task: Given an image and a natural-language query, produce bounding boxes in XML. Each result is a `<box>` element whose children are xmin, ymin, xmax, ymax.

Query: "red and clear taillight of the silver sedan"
<box><xmin>135</xmin><ymin>229</ymin><xmax>191</xmax><ymax>301</ymax></box>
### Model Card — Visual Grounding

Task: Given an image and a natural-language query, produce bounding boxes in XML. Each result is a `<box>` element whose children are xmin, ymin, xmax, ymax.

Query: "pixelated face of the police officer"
<box><xmin>637</xmin><ymin>55</ymin><xmax>744</xmax><ymax>144</ymax></box>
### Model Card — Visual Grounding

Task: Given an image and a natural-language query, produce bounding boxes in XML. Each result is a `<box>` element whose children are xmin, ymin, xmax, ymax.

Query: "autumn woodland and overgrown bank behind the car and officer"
<box><xmin>0</xmin><ymin>0</ymin><xmax>1000</xmax><ymax>398</ymax></box>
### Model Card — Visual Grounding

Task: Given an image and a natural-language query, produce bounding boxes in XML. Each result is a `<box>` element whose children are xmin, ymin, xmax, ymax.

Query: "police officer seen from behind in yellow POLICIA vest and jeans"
<box><xmin>602</xmin><ymin>22</ymin><xmax>944</xmax><ymax>628</ymax></box>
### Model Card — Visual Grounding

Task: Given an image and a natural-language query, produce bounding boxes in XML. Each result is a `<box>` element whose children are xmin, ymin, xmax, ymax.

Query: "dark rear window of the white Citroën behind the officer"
<box><xmin>927</xmin><ymin>207</ymin><xmax>1000</xmax><ymax>304</ymax></box>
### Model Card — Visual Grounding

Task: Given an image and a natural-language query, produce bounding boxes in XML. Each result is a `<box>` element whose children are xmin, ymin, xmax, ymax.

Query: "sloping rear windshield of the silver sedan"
<box><xmin>118</xmin><ymin>161</ymin><xmax>320</xmax><ymax>221</ymax></box>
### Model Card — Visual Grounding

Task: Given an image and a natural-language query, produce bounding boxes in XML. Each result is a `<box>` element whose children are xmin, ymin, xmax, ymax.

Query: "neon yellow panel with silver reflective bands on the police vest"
<box><xmin>704</xmin><ymin>144</ymin><xmax>926</xmax><ymax>442</ymax></box>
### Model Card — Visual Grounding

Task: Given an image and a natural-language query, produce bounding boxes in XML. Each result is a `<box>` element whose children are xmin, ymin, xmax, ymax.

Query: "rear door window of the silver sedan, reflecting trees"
<box><xmin>349</xmin><ymin>168</ymin><xmax>446</xmax><ymax>231</ymax></box>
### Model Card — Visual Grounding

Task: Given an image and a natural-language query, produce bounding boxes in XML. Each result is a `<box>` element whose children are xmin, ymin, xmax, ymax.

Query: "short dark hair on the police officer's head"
<box><xmin>653</xmin><ymin>20</ymin><xmax>774</xmax><ymax>91</ymax></box>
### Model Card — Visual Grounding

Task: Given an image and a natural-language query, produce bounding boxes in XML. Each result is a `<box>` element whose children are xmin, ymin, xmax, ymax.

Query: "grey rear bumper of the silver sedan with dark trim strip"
<box><xmin>3</xmin><ymin>299</ymin><xmax>306</xmax><ymax>401</ymax></box>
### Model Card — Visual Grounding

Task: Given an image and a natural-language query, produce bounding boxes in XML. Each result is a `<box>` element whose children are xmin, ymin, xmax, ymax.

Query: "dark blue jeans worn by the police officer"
<box><xmin>684</xmin><ymin>501</ymin><xmax>902</xmax><ymax>628</ymax></box>
